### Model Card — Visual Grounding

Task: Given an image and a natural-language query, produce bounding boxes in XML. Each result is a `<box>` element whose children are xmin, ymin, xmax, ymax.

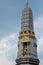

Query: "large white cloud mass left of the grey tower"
<box><xmin>0</xmin><ymin>33</ymin><xmax>18</xmax><ymax>65</ymax></box>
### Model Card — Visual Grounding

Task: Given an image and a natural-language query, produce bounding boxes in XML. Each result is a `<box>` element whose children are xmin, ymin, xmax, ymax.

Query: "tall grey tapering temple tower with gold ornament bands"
<box><xmin>16</xmin><ymin>1</ymin><xmax>39</xmax><ymax>65</ymax></box>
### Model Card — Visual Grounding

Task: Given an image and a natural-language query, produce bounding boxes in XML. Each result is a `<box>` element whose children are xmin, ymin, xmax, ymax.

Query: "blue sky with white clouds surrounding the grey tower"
<box><xmin>0</xmin><ymin>0</ymin><xmax>43</xmax><ymax>65</ymax></box>
